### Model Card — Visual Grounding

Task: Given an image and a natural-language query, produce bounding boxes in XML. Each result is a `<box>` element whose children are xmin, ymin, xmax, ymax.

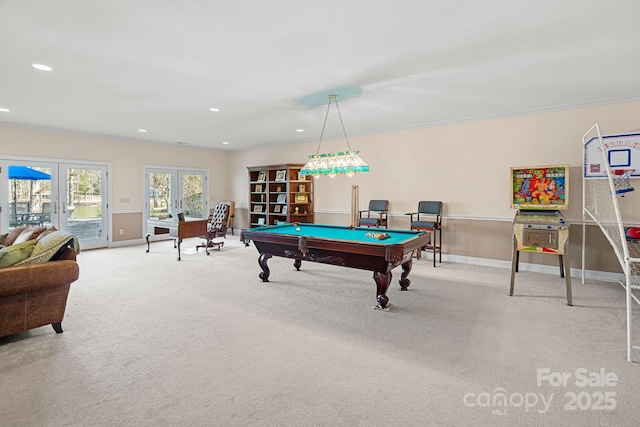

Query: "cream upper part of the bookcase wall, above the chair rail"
<box><xmin>231</xmin><ymin>102</ymin><xmax>640</xmax><ymax>221</ymax></box>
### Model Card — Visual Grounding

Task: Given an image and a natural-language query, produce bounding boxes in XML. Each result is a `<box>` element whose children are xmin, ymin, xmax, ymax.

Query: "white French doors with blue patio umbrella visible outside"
<box><xmin>0</xmin><ymin>159</ymin><xmax>109</xmax><ymax>249</ymax></box>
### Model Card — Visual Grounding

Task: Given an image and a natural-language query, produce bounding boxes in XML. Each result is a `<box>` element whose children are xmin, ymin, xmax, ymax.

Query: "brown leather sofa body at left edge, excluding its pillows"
<box><xmin>0</xmin><ymin>234</ymin><xmax>79</xmax><ymax>337</ymax></box>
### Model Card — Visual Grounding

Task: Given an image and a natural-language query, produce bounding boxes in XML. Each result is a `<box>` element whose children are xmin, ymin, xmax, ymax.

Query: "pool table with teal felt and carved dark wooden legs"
<box><xmin>240</xmin><ymin>223</ymin><xmax>429</xmax><ymax>309</ymax></box>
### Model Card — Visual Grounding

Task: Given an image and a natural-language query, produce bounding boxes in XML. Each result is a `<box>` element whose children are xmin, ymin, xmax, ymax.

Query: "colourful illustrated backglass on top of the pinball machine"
<box><xmin>510</xmin><ymin>165</ymin><xmax>569</xmax><ymax>210</ymax></box>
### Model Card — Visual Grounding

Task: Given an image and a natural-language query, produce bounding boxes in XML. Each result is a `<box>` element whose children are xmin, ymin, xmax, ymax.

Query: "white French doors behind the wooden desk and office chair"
<box><xmin>145</xmin><ymin>167</ymin><xmax>209</xmax><ymax>226</ymax></box>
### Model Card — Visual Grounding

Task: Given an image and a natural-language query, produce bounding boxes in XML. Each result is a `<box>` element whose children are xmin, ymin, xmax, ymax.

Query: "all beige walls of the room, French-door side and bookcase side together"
<box><xmin>0</xmin><ymin>102</ymin><xmax>640</xmax><ymax>272</ymax></box>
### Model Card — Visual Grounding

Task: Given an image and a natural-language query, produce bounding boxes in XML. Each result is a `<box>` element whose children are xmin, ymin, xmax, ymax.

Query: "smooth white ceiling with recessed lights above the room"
<box><xmin>0</xmin><ymin>0</ymin><xmax>640</xmax><ymax>150</ymax></box>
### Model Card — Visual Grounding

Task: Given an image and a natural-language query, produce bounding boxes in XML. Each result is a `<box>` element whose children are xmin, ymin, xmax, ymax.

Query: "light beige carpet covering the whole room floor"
<box><xmin>0</xmin><ymin>236</ymin><xmax>640</xmax><ymax>427</ymax></box>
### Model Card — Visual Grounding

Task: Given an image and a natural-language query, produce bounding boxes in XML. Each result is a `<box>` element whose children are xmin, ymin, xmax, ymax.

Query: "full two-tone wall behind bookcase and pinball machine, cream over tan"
<box><xmin>231</xmin><ymin>102</ymin><xmax>640</xmax><ymax>272</ymax></box>
